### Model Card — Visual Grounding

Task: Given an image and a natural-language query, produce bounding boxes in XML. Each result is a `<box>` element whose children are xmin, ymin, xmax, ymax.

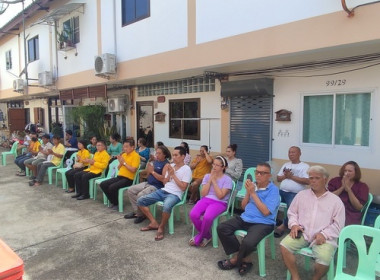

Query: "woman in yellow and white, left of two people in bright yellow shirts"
<box><xmin>65</xmin><ymin>140</ymin><xmax>90</xmax><ymax>193</ymax></box>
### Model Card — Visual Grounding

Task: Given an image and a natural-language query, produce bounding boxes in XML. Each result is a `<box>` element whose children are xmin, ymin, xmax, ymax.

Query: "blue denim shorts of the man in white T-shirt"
<box><xmin>137</xmin><ymin>189</ymin><xmax>181</xmax><ymax>213</ymax></box>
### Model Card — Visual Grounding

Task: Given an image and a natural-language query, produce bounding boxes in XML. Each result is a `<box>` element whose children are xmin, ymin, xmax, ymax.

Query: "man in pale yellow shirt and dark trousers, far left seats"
<box><xmin>29</xmin><ymin>135</ymin><xmax>65</xmax><ymax>187</ymax></box>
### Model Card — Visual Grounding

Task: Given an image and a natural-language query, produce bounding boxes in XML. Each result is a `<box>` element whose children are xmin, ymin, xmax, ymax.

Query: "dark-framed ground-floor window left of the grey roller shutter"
<box><xmin>169</xmin><ymin>99</ymin><xmax>201</xmax><ymax>140</ymax></box>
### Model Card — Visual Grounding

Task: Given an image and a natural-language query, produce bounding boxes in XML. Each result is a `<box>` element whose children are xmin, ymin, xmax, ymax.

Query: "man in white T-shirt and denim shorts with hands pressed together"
<box><xmin>137</xmin><ymin>146</ymin><xmax>191</xmax><ymax>241</ymax></box>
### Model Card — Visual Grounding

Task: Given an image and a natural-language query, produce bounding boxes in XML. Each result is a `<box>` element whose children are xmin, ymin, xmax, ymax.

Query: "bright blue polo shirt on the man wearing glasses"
<box><xmin>241</xmin><ymin>182</ymin><xmax>280</xmax><ymax>225</ymax></box>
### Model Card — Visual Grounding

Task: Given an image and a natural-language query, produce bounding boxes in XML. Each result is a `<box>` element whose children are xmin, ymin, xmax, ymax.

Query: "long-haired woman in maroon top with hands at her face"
<box><xmin>328</xmin><ymin>161</ymin><xmax>369</xmax><ymax>226</ymax></box>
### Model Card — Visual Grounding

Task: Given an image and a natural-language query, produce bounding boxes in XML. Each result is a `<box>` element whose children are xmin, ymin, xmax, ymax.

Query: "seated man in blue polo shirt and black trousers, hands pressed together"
<box><xmin>217</xmin><ymin>163</ymin><xmax>280</xmax><ymax>276</ymax></box>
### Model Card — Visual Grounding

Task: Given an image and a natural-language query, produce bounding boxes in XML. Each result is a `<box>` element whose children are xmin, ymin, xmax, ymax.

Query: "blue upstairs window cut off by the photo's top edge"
<box><xmin>121</xmin><ymin>0</ymin><xmax>150</xmax><ymax>26</ymax></box>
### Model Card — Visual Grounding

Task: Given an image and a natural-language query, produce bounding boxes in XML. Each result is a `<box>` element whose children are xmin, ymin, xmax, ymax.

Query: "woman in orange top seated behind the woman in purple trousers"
<box><xmin>189</xmin><ymin>145</ymin><xmax>212</xmax><ymax>204</ymax></box>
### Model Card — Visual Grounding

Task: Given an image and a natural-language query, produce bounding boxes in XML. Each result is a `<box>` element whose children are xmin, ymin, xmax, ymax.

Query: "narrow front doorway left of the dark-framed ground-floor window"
<box><xmin>137</xmin><ymin>101</ymin><xmax>154</xmax><ymax>148</ymax></box>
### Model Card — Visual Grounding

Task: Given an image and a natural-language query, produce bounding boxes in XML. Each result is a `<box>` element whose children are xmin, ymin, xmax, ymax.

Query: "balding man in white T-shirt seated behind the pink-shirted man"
<box><xmin>274</xmin><ymin>146</ymin><xmax>309</xmax><ymax>238</ymax></box>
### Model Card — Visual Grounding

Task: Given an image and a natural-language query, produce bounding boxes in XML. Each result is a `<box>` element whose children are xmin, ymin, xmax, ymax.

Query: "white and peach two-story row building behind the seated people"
<box><xmin>0</xmin><ymin>0</ymin><xmax>380</xmax><ymax>194</ymax></box>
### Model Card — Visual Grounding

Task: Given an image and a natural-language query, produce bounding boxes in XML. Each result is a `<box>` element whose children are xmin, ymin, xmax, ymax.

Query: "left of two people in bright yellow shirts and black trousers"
<box><xmin>72</xmin><ymin>140</ymin><xmax>110</xmax><ymax>200</ymax></box>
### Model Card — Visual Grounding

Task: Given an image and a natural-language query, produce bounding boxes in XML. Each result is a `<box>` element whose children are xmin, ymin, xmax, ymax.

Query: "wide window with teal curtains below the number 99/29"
<box><xmin>303</xmin><ymin>93</ymin><xmax>371</xmax><ymax>147</ymax></box>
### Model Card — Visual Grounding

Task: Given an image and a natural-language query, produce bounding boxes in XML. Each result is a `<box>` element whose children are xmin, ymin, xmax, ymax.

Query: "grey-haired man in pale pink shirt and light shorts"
<box><xmin>280</xmin><ymin>165</ymin><xmax>345</xmax><ymax>280</ymax></box>
